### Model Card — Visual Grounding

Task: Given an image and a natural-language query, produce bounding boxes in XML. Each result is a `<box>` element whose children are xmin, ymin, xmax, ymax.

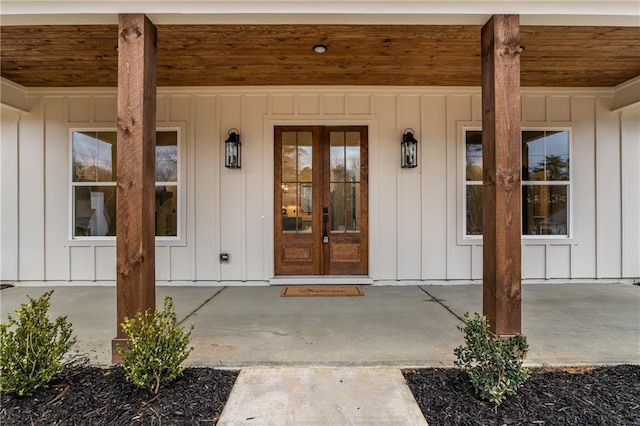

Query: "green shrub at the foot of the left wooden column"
<box><xmin>116</xmin><ymin>297</ymin><xmax>194</xmax><ymax>394</ymax></box>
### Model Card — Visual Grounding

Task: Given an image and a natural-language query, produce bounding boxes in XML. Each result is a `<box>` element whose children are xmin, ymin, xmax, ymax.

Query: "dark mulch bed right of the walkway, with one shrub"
<box><xmin>403</xmin><ymin>365</ymin><xmax>640</xmax><ymax>426</ymax></box>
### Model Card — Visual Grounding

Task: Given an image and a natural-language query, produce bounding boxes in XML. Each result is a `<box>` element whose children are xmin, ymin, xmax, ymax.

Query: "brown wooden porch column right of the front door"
<box><xmin>482</xmin><ymin>15</ymin><xmax>521</xmax><ymax>336</ymax></box>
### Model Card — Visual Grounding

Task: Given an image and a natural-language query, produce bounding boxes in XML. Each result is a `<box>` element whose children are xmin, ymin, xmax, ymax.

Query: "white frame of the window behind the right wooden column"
<box><xmin>458</xmin><ymin>122</ymin><xmax>575</xmax><ymax>243</ymax></box>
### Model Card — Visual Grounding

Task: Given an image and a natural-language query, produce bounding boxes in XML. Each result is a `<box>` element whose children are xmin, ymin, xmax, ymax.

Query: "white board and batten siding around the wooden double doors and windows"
<box><xmin>0</xmin><ymin>87</ymin><xmax>640</xmax><ymax>285</ymax></box>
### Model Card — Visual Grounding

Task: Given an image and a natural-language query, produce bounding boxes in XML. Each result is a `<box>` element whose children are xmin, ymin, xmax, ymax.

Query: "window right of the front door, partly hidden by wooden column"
<box><xmin>464</xmin><ymin>130</ymin><xmax>571</xmax><ymax>237</ymax></box>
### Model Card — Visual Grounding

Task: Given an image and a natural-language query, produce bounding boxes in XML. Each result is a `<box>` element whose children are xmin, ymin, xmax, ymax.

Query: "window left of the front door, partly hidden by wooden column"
<box><xmin>71</xmin><ymin>130</ymin><xmax>178</xmax><ymax>238</ymax></box>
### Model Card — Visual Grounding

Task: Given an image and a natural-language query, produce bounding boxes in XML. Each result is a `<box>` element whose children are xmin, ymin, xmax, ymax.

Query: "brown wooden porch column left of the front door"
<box><xmin>112</xmin><ymin>14</ymin><xmax>157</xmax><ymax>362</ymax></box>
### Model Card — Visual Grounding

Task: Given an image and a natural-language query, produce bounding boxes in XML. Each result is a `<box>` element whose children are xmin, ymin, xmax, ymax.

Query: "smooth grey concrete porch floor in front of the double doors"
<box><xmin>0</xmin><ymin>284</ymin><xmax>640</xmax><ymax>368</ymax></box>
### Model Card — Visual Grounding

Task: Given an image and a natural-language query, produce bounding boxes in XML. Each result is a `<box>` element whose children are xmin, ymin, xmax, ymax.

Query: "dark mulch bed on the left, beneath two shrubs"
<box><xmin>0</xmin><ymin>365</ymin><xmax>238</xmax><ymax>426</ymax></box>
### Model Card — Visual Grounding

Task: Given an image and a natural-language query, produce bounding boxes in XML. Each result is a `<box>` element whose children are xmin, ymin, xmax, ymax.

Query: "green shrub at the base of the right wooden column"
<box><xmin>453</xmin><ymin>313</ymin><xmax>529</xmax><ymax>406</ymax></box>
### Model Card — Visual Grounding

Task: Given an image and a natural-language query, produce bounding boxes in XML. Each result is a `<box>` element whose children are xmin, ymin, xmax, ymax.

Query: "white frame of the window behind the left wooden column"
<box><xmin>67</xmin><ymin>124</ymin><xmax>186</xmax><ymax>241</ymax></box>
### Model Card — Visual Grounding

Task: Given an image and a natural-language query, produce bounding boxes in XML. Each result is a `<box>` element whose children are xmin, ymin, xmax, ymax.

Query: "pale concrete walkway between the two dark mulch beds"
<box><xmin>218</xmin><ymin>367</ymin><xmax>427</xmax><ymax>426</ymax></box>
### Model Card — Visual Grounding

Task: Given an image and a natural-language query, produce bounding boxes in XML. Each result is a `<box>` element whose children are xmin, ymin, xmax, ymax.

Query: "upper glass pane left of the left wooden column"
<box><xmin>72</xmin><ymin>132</ymin><xmax>116</xmax><ymax>182</ymax></box>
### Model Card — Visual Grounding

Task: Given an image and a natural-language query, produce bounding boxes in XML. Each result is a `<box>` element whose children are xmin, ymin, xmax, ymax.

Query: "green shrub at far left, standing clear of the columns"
<box><xmin>0</xmin><ymin>290</ymin><xmax>76</xmax><ymax>395</ymax></box>
